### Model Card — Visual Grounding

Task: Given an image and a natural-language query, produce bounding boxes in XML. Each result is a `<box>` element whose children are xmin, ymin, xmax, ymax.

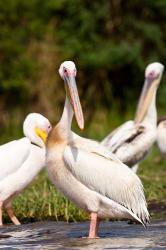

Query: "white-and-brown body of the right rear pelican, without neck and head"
<box><xmin>101</xmin><ymin>121</ymin><xmax>157</xmax><ymax>166</ymax></box>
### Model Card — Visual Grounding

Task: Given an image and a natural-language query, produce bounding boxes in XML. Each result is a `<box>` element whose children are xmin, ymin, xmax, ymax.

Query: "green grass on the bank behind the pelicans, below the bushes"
<box><xmin>4</xmin><ymin>109</ymin><xmax>166</xmax><ymax>223</ymax></box>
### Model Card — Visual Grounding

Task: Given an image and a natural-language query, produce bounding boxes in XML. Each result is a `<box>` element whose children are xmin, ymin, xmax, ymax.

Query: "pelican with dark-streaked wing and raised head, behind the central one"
<box><xmin>101</xmin><ymin>62</ymin><xmax>164</xmax><ymax>172</ymax></box>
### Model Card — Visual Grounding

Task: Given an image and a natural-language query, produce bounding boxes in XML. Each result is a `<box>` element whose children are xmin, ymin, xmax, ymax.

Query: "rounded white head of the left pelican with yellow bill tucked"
<box><xmin>23</xmin><ymin>113</ymin><xmax>52</xmax><ymax>147</ymax></box>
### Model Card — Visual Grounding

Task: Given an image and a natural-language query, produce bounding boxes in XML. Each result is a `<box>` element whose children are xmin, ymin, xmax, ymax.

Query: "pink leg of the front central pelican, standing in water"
<box><xmin>88</xmin><ymin>213</ymin><xmax>100</xmax><ymax>239</ymax></box>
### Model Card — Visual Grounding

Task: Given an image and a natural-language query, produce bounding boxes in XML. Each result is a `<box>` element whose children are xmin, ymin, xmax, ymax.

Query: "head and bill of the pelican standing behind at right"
<box><xmin>135</xmin><ymin>62</ymin><xmax>164</xmax><ymax>123</ymax></box>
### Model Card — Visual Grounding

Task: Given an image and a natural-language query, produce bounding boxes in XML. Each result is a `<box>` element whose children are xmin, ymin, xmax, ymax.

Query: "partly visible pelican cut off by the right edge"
<box><xmin>157</xmin><ymin>116</ymin><xmax>166</xmax><ymax>159</ymax></box>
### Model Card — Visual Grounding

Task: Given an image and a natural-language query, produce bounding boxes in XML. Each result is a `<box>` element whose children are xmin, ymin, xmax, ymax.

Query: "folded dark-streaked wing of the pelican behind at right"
<box><xmin>101</xmin><ymin>121</ymin><xmax>145</xmax><ymax>153</ymax></box>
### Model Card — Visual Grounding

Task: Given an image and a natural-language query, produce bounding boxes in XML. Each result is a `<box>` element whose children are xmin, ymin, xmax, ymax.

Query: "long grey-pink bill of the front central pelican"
<box><xmin>65</xmin><ymin>74</ymin><xmax>84</xmax><ymax>129</ymax></box>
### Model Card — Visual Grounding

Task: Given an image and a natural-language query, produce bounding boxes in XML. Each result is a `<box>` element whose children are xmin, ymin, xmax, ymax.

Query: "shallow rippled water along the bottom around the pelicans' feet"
<box><xmin>0</xmin><ymin>220</ymin><xmax>166</xmax><ymax>250</ymax></box>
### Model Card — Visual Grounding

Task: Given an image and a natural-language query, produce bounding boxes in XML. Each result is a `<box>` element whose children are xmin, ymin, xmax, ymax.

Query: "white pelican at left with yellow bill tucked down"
<box><xmin>0</xmin><ymin>113</ymin><xmax>51</xmax><ymax>226</ymax></box>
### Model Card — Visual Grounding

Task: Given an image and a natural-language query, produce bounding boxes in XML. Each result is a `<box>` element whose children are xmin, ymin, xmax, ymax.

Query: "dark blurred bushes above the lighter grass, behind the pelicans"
<box><xmin>0</xmin><ymin>0</ymin><xmax>166</xmax><ymax>132</ymax></box>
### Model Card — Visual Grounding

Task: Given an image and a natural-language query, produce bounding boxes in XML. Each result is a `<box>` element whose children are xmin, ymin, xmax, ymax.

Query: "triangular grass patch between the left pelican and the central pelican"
<box><xmin>9</xmin><ymin>171</ymin><xmax>87</xmax><ymax>222</ymax></box>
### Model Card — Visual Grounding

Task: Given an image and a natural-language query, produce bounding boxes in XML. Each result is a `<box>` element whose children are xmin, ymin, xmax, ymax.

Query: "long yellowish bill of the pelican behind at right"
<box><xmin>135</xmin><ymin>78</ymin><xmax>160</xmax><ymax>123</ymax></box>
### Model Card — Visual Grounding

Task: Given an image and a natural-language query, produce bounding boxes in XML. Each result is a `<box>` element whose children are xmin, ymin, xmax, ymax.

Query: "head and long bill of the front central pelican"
<box><xmin>59</xmin><ymin>61</ymin><xmax>84</xmax><ymax>129</ymax></box>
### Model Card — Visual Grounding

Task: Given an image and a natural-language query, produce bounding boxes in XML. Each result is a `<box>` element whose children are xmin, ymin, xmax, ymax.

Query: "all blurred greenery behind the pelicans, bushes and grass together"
<box><xmin>0</xmin><ymin>0</ymin><xmax>166</xmax><ymax>223</ymax></box>
